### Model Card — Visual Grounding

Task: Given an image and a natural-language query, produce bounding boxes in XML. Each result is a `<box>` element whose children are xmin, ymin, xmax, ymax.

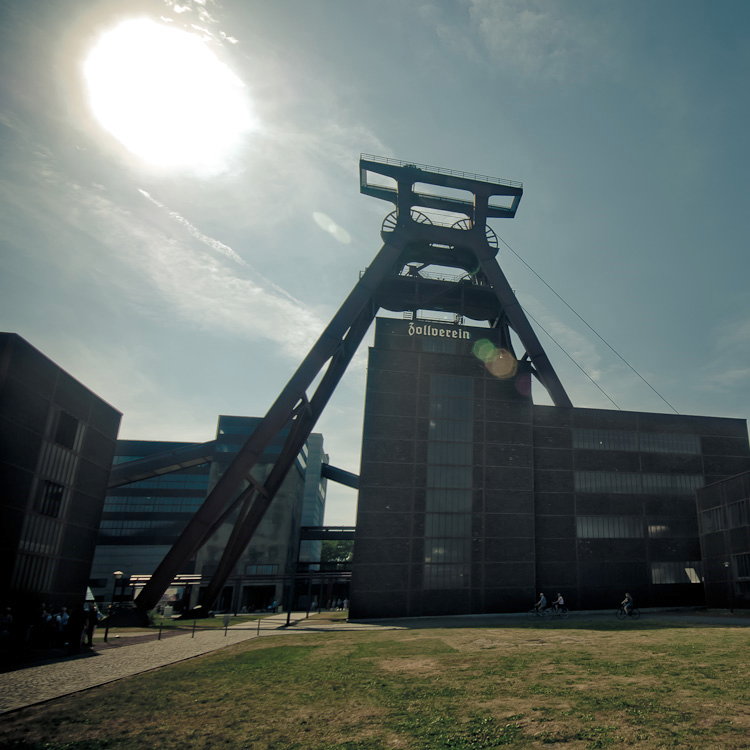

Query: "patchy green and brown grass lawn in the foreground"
<box><xmin>0</xmin><ymin>618</ymin><xmax>750</xmax><ymax>750</ymax></box>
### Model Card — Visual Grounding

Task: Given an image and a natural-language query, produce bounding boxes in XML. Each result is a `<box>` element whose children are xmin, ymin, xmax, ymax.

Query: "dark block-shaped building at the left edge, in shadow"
<box><xmin>0</xmin><ymin>333</ymin><xmax>121</xmax><ymax>606</ymax></box>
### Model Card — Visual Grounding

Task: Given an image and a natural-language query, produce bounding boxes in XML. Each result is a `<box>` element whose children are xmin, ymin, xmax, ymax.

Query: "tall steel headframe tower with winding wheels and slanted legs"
<box><xmin>136</xmin><ymin>154</ymin><xmax>572</xmax><ymax>612</ymax></box>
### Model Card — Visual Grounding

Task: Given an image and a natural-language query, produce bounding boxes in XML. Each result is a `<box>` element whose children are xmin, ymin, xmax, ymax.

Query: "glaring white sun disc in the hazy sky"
<box><xmin>83</xmin><ymin>18</ymin><xmax>256</xmax><ymax>173</ymax></box>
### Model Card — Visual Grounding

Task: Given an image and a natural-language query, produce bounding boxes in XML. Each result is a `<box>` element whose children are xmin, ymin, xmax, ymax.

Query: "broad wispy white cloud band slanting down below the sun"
<box><xmin>19</xmin><ymin>153</ymin><xmax>323</xmax><ymax>358</ymax></box>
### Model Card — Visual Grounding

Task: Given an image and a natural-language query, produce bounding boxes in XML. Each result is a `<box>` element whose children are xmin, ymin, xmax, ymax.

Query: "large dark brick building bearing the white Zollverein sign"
<box><xmin>350</xmin><ymin>318</ymin><xmax>750</xmax><ymax>618</ymax></box>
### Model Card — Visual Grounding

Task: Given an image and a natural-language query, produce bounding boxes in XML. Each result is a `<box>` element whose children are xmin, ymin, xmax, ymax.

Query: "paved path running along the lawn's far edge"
<box><xmin>0</xmin><ymin>610</ymin><xmax>750</xmax><ymax>714</ymax></box>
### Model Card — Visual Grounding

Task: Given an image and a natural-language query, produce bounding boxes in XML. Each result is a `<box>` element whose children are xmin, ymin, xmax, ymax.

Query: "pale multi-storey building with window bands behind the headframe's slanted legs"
<box><xmin>91</xmin><ymin>415</ymin><xmax>328</xmax><ymax>610</ymax></box>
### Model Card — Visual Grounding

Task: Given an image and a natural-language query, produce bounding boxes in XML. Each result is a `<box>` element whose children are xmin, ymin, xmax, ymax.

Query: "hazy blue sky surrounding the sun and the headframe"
<box><xmin>0</xmin><ymin>0</ymin><xmax>750</xmax><ymax>523</ymax></box>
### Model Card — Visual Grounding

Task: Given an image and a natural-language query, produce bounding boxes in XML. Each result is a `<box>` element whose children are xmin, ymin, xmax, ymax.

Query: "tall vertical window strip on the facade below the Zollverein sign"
<box><xmin>423</xmin><ymin>374</ymin><xmax>474</xmax><ymax>590</ymax></box>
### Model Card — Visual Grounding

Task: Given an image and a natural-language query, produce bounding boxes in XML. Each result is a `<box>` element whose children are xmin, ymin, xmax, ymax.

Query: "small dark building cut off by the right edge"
<box><xmin>697</xmin><ymin>472</ymin><xmax>750</xmax><ymax>608</ymax></box>
